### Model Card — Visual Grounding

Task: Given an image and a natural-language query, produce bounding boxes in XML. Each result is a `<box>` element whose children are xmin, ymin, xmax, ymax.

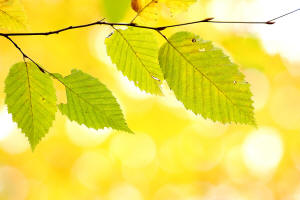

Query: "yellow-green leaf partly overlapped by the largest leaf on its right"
<box><xmin>106</xmin><ymin>28</ymin><xmax>162</xmax><ymax>94</ymax></box>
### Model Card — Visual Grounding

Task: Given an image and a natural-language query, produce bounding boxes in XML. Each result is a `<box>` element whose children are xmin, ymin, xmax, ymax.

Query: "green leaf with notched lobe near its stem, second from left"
<box><xmin>54</xmin><ymin>70</ymin><xmax>132</xmax><ymax>133</ymax></box>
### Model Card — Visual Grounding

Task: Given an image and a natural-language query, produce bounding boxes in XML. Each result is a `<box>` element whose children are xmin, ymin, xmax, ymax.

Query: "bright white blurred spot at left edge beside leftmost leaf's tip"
<box><xmin>0</xmin><ymin>129</ymin><xmax>30</xmax><ymax>154</ymax></box>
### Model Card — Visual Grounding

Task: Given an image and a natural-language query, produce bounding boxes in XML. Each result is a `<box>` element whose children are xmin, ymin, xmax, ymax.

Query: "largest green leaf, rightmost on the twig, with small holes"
<box><xmin>159</xmin><ymin>32</ymin><xmax>255</xmax><ymax>124</ymax></box>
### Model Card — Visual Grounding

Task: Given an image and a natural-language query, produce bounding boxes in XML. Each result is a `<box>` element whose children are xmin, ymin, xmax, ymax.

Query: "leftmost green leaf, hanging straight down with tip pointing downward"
<box><xmin>5</xmin><ymin>63</ymin><xmax>57</xmax><ymax>149</ymax></box>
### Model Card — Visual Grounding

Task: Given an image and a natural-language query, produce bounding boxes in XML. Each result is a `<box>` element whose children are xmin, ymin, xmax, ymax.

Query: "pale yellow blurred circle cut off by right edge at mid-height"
<box><xmin>269</xmin><ymin>85</ymin><xmax>300</xmax><ymax>130</ymax></box>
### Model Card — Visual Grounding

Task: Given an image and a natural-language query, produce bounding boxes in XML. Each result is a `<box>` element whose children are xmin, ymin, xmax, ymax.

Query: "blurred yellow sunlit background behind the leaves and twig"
<box><xmin>0</xmin><ymin>0</ymin><xmax>300</xmax><ymax>200</ymax></box>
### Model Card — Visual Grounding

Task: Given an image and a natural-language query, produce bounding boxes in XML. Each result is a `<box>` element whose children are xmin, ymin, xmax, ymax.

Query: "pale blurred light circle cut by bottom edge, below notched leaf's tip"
<box><xmin>108</xmin><ymin>183</ymin><xmax>144</xmax><ymax>200</ymax></box>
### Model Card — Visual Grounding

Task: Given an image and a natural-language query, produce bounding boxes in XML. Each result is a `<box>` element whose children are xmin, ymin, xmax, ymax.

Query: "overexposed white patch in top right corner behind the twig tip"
<box><xmin>208</xmin><ymin>0</ymin><xmax>300</xmax><ymax>61</ymax></box>
